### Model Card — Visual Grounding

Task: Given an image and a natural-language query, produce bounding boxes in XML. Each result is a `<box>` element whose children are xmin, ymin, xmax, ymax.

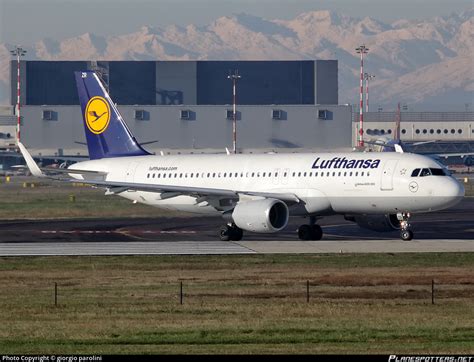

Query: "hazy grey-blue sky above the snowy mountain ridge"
<box><xmin>0</xmin><ymin>0</ymin><xmax>474</xmax><ymax>46</ymax></box>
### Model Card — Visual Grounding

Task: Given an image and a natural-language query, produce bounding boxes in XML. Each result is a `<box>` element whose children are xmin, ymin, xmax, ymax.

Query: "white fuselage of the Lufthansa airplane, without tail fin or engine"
<box><xmin>70</xmin><ymin>152</ymin><xmax>464</xmax><ymax>215</ymax></box>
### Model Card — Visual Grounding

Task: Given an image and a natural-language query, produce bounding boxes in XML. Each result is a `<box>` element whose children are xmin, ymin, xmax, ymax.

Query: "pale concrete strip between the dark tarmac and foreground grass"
<box><xmin>0</xmin><ymin>239</ymin><xmax>474</xmax><ymax>256</ymax></box>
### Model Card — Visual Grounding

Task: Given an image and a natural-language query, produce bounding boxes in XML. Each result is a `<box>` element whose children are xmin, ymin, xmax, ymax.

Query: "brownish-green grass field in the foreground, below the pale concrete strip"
<box><xmin>0</xmin><ymin>253</ymin><xmax>474</xmax><ymax>354</ymax></box>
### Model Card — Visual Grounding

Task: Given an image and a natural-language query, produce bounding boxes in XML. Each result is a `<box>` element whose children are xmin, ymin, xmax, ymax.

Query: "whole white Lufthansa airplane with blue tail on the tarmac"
<box><xmin>18</xmin><ymin>71</ymin><xmax>464</xmax><ymax>241</ymax></box>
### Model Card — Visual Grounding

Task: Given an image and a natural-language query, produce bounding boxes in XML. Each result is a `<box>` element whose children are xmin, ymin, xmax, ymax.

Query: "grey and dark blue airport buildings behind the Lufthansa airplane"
<box><xmin>0</xmin><ymin>60</ymin><xmax>474</xmax><ymax>170</ymax></box>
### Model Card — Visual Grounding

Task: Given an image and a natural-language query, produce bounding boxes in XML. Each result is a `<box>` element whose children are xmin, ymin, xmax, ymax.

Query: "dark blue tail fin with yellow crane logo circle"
<box><xmin>74</xmin><ymin>71</ymin><xmax>150</xmax><ymax>160</ymax></box>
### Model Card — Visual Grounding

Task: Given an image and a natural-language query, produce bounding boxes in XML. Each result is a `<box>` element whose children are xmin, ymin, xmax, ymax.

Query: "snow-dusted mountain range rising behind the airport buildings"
<box><xmin>0</xmin><ymin>8</ymin><xmax>474</xmax><ymax>111</ymax></box>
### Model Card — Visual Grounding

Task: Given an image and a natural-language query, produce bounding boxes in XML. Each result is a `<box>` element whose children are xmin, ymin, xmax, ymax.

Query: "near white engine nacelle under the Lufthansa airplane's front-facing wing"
<box><xmin>232</xmin><ymin>199</ymin><xmax>290</xmax><ymax>233</ymax></box>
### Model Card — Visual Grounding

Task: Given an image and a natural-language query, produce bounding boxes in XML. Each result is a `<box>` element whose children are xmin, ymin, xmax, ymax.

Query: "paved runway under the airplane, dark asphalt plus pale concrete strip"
<box><xmin>0</xmin><ymin>198</ymin><xmax>474</xmax><ymax>256</ymax></box>
